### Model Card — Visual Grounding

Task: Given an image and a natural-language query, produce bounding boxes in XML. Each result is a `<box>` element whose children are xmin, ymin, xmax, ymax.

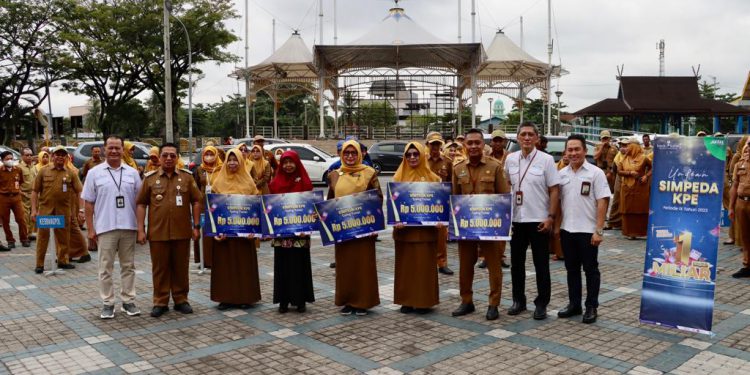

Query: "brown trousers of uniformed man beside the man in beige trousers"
<box><xmin>149</xmin><ymin>239</ymin><xmax>190</xmax><ymax>306</ymax></box>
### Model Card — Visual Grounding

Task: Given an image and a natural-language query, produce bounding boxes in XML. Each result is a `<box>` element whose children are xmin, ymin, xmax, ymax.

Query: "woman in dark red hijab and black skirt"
<box><xmin>268</xmin><ymin>150</ymin><xmax>315</xmax><ymax>313</ymax></box>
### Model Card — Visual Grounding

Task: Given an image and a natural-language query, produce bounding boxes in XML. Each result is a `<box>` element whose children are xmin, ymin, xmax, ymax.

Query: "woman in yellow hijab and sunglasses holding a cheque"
<box><xmin>393</xmin><ymin>142</ymin><xmax>441</xmax><ymax>314</ymax></box>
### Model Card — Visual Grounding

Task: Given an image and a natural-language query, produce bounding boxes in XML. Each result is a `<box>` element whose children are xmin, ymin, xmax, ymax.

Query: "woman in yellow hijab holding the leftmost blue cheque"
<box><xmin>211</xmin><ymin>149</ymin><xmax>260</xmax><ymax>310</ymax></box>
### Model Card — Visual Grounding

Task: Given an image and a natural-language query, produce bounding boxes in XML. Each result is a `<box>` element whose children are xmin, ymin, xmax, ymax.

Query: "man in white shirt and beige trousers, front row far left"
<box><xmin>81</xmin><ymin>135</ymin><xmax>142</xmax><ymax>319</ymax></box>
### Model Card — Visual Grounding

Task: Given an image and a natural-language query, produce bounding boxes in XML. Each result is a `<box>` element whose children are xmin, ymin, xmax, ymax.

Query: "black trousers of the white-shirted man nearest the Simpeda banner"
<box><xmin>560</xmin><ymin>230</ymin><xmax>602</xmax><ymax>308</ymax></box>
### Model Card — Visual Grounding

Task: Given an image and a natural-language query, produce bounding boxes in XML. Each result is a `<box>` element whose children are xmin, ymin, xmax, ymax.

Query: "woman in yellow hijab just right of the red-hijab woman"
<box><xmin>328</xmin><ymin>140</ymin><xmax>384</xmax><ymax>316</ymax></box>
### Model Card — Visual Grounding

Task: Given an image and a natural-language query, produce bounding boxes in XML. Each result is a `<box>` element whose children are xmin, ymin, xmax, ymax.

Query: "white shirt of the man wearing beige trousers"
<box><xmin>81</xmin><ymin>162</ymin><xmax>143</xmax><ymax>235</ymax></box>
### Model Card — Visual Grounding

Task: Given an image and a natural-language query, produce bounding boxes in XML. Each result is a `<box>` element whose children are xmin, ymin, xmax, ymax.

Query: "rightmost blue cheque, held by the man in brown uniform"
<box><xmin>448</xmin><ymin>194</ymin><xmax>513</xmax><ymax>241</ymax></box>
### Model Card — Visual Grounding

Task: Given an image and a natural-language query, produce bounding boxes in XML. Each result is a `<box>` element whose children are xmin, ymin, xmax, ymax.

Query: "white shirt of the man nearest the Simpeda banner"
<box><xmin>559</xmin><ymin>161</ymin><xmax>611</xmax><ymax>233</ymax></box>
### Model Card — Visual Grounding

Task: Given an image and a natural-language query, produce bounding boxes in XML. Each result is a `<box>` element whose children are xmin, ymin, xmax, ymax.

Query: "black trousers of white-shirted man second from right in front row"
<box><xmin>510</xmin><ymin>223</ymin><xmax>551</xmax><ymax>307</ymax></box>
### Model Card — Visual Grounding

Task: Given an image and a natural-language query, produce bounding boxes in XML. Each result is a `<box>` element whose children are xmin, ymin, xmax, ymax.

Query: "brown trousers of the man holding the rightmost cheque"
<box><xmin>458</xmin><ymin>241</ymin><xmax>505</xmax><ymax>306</ymax></box>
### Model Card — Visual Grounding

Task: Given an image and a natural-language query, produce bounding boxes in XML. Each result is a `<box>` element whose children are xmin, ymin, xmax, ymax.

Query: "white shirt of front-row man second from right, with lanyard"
<box><xmin>505</xmin><ymin>149</ymin><xmax>560</xmax><ymax>223</ymax></box>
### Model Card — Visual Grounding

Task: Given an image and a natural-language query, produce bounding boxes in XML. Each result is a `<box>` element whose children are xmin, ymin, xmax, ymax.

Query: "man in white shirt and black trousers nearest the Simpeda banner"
<box><xmin>557</xmin><ymin>134</ymin><xmax>611</xmax><ymax>324</ymax></box>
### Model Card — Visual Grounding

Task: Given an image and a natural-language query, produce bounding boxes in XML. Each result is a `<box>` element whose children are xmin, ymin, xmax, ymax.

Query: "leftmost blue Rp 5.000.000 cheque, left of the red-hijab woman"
<box><xmin>203</xmin><ymin>194</ymin><xmax>263</xmax><ymax>237</ymax></box>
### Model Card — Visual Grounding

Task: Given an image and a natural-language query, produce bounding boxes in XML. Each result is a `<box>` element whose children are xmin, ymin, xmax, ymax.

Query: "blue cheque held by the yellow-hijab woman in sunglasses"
<box><xmin>386</xmin><ymin>182</ymin><xmax>451</xmax><ymax>226</ymax></box>
